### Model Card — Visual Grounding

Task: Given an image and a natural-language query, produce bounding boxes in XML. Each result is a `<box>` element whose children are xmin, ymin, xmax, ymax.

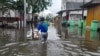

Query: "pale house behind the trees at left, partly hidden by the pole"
<box><xmin>0</xmin><ymin>9</ymin><xmax>32</xmax><ymax>24</ymax></box>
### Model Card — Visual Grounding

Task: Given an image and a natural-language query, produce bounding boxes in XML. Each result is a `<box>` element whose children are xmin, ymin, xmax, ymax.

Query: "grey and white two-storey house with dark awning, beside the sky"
<box><xmin>59</xmin><ymin>0</ymin><xmax>91</xmax><ymax>24</ymax></box>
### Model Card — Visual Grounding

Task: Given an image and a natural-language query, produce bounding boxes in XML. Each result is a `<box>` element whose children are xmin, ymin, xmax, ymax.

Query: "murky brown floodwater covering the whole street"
<box><xmin>0</xmin><ymin>25</ymin><xmax>100</xmax><ymax>56</ymax></box>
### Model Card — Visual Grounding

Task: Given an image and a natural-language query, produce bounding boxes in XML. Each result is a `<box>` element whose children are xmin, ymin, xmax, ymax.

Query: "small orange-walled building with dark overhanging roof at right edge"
<box><xmin>82</xmin><ymin>0</ymin><xmax>100</xmax><ymax>26</ymax></box>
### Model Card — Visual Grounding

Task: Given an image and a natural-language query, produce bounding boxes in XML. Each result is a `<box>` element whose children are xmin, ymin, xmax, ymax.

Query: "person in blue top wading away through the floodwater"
<box><xmin>37</xmin><ymin>17</ymin><xmax>48</xmax><ymax>43</ymax></box>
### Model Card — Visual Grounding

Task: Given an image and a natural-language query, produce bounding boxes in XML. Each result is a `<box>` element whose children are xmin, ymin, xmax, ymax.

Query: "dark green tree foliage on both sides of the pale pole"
<box><xmin>0</xmin><ymin>0</ymin><xmax>51</xmax><ymax>16</ymax></box>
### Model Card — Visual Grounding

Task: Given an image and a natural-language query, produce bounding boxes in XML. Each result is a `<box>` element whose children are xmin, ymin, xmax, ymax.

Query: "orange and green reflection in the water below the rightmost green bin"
<box><xmin>84</xmin><ymin>30</ymin><xmax>99</xmax><ymax>51</ymax></box>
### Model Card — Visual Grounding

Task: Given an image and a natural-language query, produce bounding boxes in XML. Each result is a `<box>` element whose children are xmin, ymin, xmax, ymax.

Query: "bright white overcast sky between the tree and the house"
<box><xmin>41</xmin><ymin>0</ymin><xmax>61</xmax><ymax>16</ymax></box>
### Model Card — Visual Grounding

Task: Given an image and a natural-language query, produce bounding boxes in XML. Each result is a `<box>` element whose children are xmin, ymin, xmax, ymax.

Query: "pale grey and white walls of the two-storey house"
<box><xmin>61</xmin><ymin>0</ymin><xmax>91</xmax><ymax>18</ymax></box>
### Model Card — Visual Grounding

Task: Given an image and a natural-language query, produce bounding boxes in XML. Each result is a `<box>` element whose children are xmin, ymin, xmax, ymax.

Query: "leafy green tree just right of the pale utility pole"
<box><xmin>28</xmin><ymin>0</ymin><xmax>51</xmax><ymax>21</ymax></box>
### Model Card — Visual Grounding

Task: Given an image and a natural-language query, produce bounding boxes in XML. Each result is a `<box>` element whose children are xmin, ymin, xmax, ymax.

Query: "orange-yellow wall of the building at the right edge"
<box><xmin>86</xmin><ymin>5</ymin><xmax>100</xmax><ymax>26</ymax></box>
